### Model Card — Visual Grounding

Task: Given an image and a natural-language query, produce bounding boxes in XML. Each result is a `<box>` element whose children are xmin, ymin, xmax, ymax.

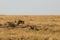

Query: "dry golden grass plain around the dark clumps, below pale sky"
<box><xmin>0</xmin><ymin>15</ymin><xmax>60</xmax><ymax>40</ymax></box>
